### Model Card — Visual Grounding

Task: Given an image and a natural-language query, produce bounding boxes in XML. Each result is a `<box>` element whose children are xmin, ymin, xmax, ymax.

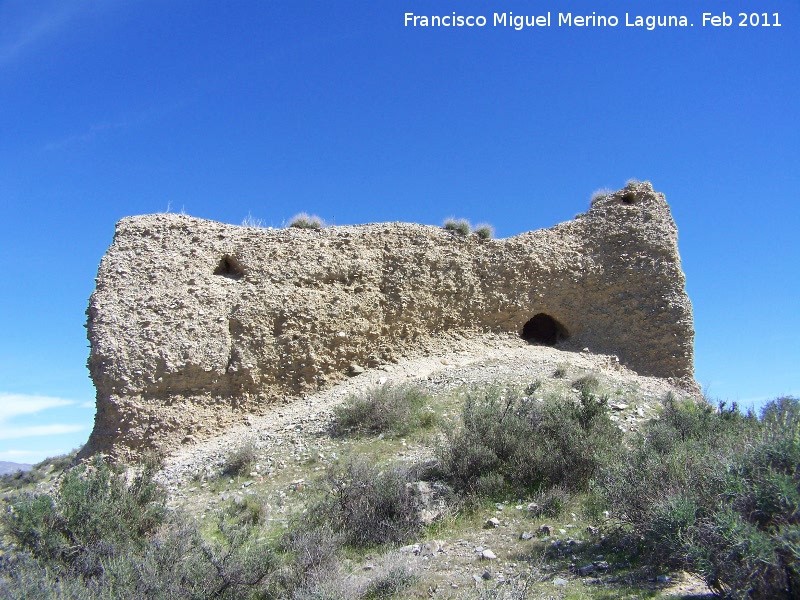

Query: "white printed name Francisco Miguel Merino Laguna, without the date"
<box><xmin>404</xmin><ymin>12</ymin><xmax>690</xmax><ymax>31</ymax></box>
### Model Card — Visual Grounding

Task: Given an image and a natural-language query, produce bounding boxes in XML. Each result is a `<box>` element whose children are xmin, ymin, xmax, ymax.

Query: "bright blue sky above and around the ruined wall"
<box><xmin>0</xmin><ymin>0</ymin><xmax>800</xmax><ymax>462</ymax></box>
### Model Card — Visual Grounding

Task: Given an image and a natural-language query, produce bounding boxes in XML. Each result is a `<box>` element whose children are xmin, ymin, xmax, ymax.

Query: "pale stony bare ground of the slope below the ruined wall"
<box><xmin>147</xmin><ymin>334</ymin><xmax>708</xmax><ymax>598</ymax></box>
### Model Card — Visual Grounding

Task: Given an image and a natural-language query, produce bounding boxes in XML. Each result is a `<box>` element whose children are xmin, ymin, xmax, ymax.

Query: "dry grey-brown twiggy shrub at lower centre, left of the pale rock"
<box><xmin>309</xmin><ymin>458</ymin><xmax>420</xmax><ymax>547</ymax></box>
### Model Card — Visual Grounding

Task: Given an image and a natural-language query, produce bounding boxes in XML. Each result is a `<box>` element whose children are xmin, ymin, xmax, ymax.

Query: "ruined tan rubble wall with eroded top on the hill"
<box><xmin>85</xmin><ymin>183</ymin><xmax>694</xmax><ymax>454</ymax></box>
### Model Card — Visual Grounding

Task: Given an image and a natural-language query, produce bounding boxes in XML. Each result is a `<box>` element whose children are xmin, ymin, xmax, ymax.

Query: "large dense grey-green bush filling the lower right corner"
<box><xmin>596</xmin><ymin>397</ymin><xmax>800</xmax><ymax>600</ymax></box>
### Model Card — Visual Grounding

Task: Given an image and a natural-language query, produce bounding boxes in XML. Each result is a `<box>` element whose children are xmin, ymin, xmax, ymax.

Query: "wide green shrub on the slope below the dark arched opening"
<box><xmin>437</xmin><ymin>387</ymin><xmax>621</xmax><ymax>493</ymax></box>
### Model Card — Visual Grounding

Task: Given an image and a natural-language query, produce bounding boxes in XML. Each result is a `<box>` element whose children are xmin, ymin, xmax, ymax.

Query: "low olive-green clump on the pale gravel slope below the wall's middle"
<box><xmin>332</xmin><ymin>384</ymin><xmax>436</xmax><ymax>435</ymax></box>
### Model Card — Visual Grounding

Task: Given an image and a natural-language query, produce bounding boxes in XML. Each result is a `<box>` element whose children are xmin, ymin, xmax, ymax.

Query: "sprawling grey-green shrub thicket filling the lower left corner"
<box><xmin>0</xmin><ymin>457</ymin><xmax>281</xmax><ymax>600</ymax></box>
